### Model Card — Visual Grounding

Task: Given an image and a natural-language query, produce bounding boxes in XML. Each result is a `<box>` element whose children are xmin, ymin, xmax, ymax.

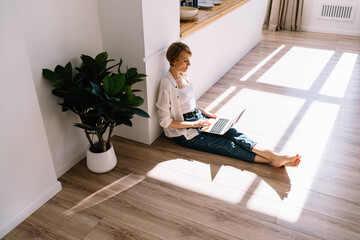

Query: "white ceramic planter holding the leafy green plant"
<box><xmin>86</xmin><ymin>143</ymin><xmax>117</xmax><ymax>173</ymax></box>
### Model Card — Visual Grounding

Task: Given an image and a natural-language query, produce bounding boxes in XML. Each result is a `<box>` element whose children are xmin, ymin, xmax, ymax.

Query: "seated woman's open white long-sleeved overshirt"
<box><xmin>156</xmin><ymin>72</ymin><xmax>199</xmax><ymax>140</ymax></box>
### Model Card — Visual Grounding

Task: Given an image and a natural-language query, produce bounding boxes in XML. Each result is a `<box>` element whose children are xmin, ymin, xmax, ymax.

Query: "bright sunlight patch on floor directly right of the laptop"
<box><xmin>234</xmin><ymin>89</ymin><xmax>305</xmax><ymax>149</ymax></box>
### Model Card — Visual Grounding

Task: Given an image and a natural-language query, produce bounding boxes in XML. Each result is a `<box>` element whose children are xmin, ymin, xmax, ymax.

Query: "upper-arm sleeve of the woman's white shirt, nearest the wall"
<box><xmin>156</xmin><ymin>79</ymin><xmax>173</xmax><ymax>128</ymax></box>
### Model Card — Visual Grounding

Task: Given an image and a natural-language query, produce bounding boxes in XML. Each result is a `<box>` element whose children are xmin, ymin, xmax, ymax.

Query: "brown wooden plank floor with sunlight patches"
<box><xmin>4</xmin><ymin>31</ymin><xmax>360</xmax><ymax>240</ymax></box>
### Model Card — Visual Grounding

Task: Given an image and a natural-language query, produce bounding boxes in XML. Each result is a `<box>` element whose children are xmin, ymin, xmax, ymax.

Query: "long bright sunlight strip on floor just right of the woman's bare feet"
<box><xmin>279</xmin><ymin>101</ymin><xmax>340</xmax><ymax>223</ymax></box>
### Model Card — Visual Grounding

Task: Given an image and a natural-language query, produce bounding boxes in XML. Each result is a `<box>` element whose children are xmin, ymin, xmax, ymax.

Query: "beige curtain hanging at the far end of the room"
<box><xmin>263</xmin><ymin>0</ymin><xmax>304</xmax><ymax>31</ymax></box>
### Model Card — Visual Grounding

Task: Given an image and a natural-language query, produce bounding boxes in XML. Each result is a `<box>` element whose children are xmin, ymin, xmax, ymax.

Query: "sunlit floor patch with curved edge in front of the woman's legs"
<box><xmin>147</xmin><ymin>158</ymin><xmax>291</xmax><ymax>218</ymax></box>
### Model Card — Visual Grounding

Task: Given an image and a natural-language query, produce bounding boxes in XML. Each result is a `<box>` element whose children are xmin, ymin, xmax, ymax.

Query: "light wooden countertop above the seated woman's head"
<box><xmin>180</xmin><ymin>0</ymin><xmax>249</xmax><ymax>38</ymax></box>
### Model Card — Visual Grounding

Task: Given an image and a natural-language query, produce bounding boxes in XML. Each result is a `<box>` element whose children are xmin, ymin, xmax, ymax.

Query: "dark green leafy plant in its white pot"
<box><xmin>42</xmin><ymin>52</ymin><xmax>149</xmax><ymax>172</ymax></box>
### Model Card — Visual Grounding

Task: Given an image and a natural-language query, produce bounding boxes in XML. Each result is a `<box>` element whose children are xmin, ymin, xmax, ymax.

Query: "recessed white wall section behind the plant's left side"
<box><xmin>12</xmin><ymin>0</ymin><xmax>102</xmax><ymax>177</ymax></box>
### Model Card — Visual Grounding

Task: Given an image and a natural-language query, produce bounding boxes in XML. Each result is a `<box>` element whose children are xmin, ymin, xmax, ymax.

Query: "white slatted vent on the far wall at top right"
<box><xmin>319</xmin><ymin>1</ymin><xmax>356</xmax><ymax>21</ymax></box>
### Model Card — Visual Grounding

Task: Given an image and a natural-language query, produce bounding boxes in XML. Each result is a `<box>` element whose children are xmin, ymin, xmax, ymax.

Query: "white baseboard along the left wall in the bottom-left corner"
<box><xmin>0</xmin><ymin>181</ymin><xmax>62</xmax><ymax>239</ymax></box>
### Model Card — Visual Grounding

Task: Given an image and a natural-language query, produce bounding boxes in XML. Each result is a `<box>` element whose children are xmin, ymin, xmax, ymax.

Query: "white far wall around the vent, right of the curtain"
<box><xmin>301</xmin><ymin>0</ymin><xmax>360</xmax><ymax>36</ymax></box>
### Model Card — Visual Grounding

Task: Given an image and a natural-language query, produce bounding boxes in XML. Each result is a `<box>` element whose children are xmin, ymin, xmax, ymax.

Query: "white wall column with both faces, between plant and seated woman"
<box><xmin>98</xmin><ymin>0</ymin><xmax>180</xmax><ymax>144</ymax></box>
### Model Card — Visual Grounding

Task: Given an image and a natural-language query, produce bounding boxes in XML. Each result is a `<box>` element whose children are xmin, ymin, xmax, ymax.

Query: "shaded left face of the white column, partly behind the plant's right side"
<box><xmin>98</xmin><ymin>0</ymin><xmax>149</xmax><ymax>143</ymax></box>
